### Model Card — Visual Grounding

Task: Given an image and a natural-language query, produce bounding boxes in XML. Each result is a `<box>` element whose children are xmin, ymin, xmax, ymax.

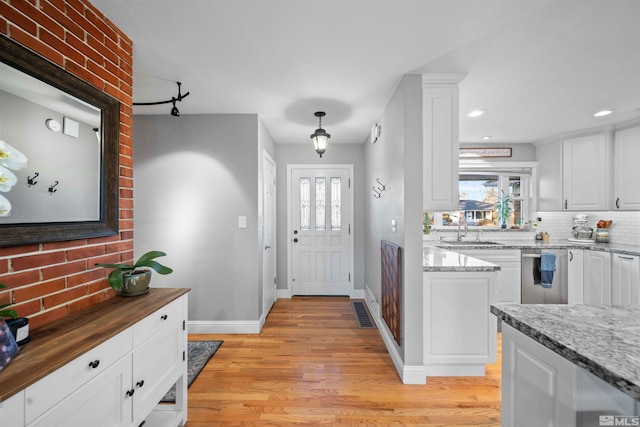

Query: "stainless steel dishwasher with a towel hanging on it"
<box><xmin>521</xmin><ymin>249</ymin><xmax>569</xmax><ymax>304</ymax></box>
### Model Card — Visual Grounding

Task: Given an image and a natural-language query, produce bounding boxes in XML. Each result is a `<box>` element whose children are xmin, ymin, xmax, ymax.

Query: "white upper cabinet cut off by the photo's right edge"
<box><xmin>613</xmin><ymin>126</ymin><xmax>640</xmax><ymax>210</ymax></box>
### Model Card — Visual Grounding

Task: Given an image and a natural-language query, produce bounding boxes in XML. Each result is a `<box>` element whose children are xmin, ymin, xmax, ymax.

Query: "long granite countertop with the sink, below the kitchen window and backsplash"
<box><xmin>433</xmin><ymin>239</ymin><xmax>640</xmax><ymax>256</ymax></box>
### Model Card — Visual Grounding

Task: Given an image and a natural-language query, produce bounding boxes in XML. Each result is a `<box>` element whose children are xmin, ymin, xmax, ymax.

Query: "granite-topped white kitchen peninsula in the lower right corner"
<box><xmin>491</xmin><ymin>304</ymin><xmax>640</xmax><ymax>426</ymax></box>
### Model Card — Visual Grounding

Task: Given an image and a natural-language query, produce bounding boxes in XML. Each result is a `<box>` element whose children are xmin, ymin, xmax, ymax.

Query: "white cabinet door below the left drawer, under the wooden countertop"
<box><xmin>29</xmin><ymin>356</ymin><xmax>132</xmax><ymax>427</ymax></box>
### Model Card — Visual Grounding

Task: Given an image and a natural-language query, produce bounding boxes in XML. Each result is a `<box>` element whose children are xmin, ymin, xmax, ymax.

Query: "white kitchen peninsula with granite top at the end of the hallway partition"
<box><xmin>423</xmin><ymin>247</ymin><xmax>500</xmax><ymax>377</ymax></box>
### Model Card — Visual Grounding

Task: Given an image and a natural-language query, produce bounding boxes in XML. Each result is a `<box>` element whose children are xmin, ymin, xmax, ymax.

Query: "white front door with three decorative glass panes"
<box><xmin>288</xmin><ymin>165</ymin><xmax>353</xmax><ymax>295</ymax></box>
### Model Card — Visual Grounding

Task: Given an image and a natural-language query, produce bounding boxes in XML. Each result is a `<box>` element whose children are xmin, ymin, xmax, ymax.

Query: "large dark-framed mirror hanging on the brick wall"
<box><xmin>0</xmin><ymin>37</ymin><xmax>120</xmax><ymax>246</ymax></box>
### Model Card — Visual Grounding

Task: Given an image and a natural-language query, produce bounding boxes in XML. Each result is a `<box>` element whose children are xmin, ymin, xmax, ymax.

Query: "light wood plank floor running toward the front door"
<box><xmin>187</xmin><ymin>297</ymin><xmax>500</xmax><ymax>427</ymax></box>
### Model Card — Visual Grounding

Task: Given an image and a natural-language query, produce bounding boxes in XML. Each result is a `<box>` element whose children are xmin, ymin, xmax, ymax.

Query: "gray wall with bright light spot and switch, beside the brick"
<box><xmin>133</xmin><ymin>114</ymin><xmax>264</xmax><ymax>321</ymax></box>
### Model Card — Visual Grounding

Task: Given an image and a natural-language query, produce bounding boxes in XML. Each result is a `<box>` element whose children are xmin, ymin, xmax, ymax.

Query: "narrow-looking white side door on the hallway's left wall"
<box><xmin>262</xmin><ymin>152</ymin><xmax>277</xmax><ymax>315</ymax></box>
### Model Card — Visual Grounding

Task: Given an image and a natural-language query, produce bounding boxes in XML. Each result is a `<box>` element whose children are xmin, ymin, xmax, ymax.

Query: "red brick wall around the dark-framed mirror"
<box><xmin>0</xmin><ymin>0</ymin><xmax>133</xmax><ymax>329</ymax></box>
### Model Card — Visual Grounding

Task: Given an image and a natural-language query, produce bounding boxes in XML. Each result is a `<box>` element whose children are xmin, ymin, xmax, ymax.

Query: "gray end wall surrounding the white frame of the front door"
<box><xmin>276</xmin><ymin>144</ymin><xmax>369</xmax><ymax>290</ymax></box>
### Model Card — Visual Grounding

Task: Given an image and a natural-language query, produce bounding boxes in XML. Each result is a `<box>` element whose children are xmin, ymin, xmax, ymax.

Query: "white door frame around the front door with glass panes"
<box><xmin>286</xmin><ymin>164</ymin><xmax>355</xmax><ymax>298</ymax></box>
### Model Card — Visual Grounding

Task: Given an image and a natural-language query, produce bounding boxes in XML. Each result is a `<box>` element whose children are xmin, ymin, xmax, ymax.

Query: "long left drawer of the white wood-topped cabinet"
<box><xmin>25</xmin><ymin>328</ymin><xmax>132</xmax><ymax>424</ymax></box>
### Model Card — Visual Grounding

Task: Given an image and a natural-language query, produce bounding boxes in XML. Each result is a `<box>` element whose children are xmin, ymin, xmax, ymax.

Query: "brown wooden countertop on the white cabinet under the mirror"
<box><xmin>0</xmin><ymin>288</ymin><xmax>190</xmax><ymax>402</ymax></box>
